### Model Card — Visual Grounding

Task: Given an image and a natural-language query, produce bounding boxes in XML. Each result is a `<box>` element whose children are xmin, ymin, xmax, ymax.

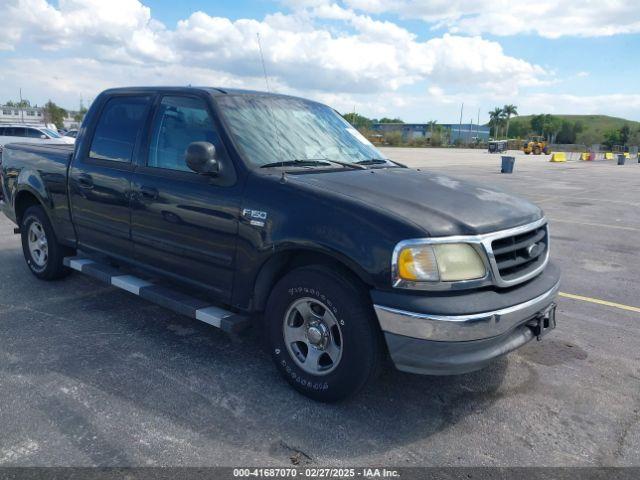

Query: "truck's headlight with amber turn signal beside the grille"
<box><xmin>395</xmin><ymin>243</ymin><xmax>487</xmax><ymax>282</ymax></box>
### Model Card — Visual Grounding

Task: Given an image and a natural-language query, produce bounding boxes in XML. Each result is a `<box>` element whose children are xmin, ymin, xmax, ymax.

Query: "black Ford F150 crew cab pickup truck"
<box><xmin>2</xmin><ymin>87</ymin><xmax>560</xmax><ymax>401</ymax></box>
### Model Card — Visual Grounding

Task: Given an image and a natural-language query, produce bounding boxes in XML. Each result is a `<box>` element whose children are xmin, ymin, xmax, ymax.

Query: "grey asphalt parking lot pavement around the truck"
<box><xmin>0</xmin><ymin>149</ymin><xmax>640</xmax><ymax>467</ymax></box>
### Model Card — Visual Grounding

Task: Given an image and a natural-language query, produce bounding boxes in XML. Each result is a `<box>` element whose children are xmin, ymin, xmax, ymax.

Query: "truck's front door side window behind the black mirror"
<box><xmin>147</xmin><ymin>96</ymin><xmax>220</xmax><ymax>172</ymax></box>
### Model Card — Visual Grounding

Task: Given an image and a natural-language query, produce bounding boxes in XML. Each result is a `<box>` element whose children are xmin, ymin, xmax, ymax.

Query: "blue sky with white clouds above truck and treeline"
<box><xmin>0</xmin><ymin>0</ymin><xmax>640</xmax><ymax>123</ymax></box>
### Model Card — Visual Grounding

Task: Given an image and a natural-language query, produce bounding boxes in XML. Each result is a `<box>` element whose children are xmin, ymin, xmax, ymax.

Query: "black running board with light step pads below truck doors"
<box><xmin>64</xmin><ymin>257</ymin><xmax>249</xmax><ymax>333</ymax></box>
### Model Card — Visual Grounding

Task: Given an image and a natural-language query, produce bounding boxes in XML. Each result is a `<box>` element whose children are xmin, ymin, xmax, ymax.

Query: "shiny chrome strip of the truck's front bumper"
<box><xmin>374</xmin><ymin>282</ymin><xmax>560</xmax><ymax>342</ymax></box>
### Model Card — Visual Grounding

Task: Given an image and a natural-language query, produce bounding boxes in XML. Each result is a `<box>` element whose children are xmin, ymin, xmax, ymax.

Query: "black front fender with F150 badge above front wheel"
<box><xmin>233</xmin><ymin>175</ymin><xmax>419</xmax><ymax>308</ymax></box>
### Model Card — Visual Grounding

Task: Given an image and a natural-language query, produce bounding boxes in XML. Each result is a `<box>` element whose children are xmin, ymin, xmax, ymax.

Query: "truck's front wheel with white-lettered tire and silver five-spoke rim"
<box><xmin>265</xmin><ymin>265</ymin><xmax>382</xmax><ymax>402</ymax></box>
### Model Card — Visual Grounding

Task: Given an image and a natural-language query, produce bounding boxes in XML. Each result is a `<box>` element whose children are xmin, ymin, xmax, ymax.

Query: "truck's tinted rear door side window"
<box><xmin>89</xmin><ymin>96</ymin><xmax>149</xmax><ymax>163</ymax></box>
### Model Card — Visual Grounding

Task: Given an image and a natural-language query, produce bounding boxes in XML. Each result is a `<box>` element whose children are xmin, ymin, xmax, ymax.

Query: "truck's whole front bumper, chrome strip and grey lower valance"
<box><xmin>372</xmin><ymin>264</ymin><xmax>560</xmax><ymax>375</ymax></box>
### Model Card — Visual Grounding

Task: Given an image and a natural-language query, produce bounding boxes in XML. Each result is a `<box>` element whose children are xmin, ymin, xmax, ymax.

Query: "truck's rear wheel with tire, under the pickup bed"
<box><xmin>20</xmin><ymin>206</ymin><xmax>73</xmax><ymax>280</ymax></box>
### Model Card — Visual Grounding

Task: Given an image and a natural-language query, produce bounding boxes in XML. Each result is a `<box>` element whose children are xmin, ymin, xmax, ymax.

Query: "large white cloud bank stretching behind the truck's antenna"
<box><xmin>0</xmin><ymin>0</ymin><xmax>544</xmax><ymax>98</ymax></box>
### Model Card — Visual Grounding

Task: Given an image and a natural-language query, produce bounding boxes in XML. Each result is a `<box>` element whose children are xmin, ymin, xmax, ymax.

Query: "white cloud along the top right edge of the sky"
<box><xmin>340</xmin><ymin>0</ymin><xmax>640</xmax><ymax>38</ymax></box>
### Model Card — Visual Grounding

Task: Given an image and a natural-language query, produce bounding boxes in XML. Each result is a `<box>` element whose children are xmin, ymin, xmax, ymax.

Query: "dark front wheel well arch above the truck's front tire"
<box><xmin>253</xmin><ymin>250</ymin><xmax>371</xmax><ymax>311</ymax></box>
